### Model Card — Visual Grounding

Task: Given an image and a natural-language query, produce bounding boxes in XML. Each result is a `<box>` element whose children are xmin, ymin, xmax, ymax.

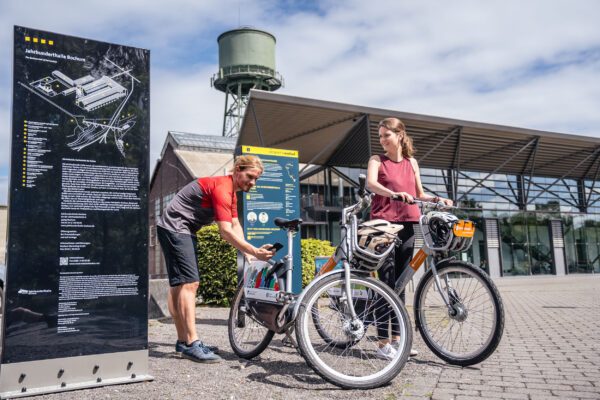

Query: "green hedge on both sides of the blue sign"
<box><xmin>197</xmin><ymin>224</ymin><xmax>335</xmax><ymax>307</ymax></box>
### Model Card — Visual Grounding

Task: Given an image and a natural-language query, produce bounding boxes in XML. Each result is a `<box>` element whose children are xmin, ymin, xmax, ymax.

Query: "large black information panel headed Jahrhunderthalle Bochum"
<box><xmin>2</xmin><ymin>27</ymin><xmax>150</xmax><ymax>364</ymax></box>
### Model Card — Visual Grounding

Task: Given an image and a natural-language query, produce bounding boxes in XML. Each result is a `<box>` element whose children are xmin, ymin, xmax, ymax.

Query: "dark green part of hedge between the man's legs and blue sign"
<box><xmin>196</xmin><ymin>224</ymin><xmax>237</xmax><ymax>307</ymax></box>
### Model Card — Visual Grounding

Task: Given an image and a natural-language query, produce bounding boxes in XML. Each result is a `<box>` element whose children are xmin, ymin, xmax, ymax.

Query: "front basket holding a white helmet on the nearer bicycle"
<box><xmin>354</xmin><ymin>219</ymin><xmax>402</xmax><ymax>271</ymax></box>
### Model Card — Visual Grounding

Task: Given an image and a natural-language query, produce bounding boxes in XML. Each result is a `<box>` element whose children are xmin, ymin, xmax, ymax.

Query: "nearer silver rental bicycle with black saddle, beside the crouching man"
<box><xmin>228</xmin><ymin>177</ymin><xmax>412</xmax><ymax>389</ymax></box>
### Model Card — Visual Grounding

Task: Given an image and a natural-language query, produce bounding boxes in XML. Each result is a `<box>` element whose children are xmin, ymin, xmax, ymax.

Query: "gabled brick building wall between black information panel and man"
<box><xmin>148</xmin><ymin>144</ymin><xmax>194</xmax><ymax>278</ymax></box>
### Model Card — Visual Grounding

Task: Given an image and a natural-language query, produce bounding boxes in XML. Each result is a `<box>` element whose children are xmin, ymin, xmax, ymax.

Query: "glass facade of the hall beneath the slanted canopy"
<box><xmin>301</xmin><ymin>168</ymin><xmax>600</xmax><ymax>276</ymax></box>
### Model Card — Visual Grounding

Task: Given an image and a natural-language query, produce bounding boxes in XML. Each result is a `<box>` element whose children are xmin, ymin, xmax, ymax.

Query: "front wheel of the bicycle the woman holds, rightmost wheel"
<box><xmin>415</xmin><ymin>261</ymin><xmax>504</xmax><ymax>366</ymax></box>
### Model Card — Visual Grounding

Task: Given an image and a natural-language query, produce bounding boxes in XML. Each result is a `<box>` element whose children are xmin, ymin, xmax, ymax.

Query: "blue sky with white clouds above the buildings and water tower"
<box><xmin>0</xmin><ymin>0</ymin><xmax>600</xmax><ymax>204</ymax></box>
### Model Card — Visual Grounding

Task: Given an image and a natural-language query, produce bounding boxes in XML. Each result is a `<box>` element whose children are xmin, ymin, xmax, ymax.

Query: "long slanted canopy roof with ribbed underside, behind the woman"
<box><xmin>237</xmin><ymin>90</ymin><xmax>600</xmax><ymax>180</ymax></box>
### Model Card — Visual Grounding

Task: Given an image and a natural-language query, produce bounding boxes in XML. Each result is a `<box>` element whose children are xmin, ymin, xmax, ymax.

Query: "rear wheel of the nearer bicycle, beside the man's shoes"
<box><xmin>227</xmin><ymin>284</ymin><xmax>275</xmax><ymax>360</ymax></box>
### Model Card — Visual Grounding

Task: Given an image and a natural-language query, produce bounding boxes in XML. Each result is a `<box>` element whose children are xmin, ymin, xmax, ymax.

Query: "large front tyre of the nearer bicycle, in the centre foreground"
<box><xmin>295</xmin><ymin>274</ymin><xmax>412</xmax><ymax>389</ymax></box>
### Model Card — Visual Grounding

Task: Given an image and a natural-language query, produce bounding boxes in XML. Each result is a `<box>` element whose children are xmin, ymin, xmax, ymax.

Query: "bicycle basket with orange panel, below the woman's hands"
<box><xmin>419</xmin><ymin>211</ymin><xmax>475</xmax><ymax>252</ymax></box>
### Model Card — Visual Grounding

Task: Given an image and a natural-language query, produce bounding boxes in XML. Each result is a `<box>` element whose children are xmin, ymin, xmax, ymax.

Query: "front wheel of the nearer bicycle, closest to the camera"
<box><xmin>296</xmin><ymin>274</ymin><xmax>412</xmax><ymax>389</ymax></box>
